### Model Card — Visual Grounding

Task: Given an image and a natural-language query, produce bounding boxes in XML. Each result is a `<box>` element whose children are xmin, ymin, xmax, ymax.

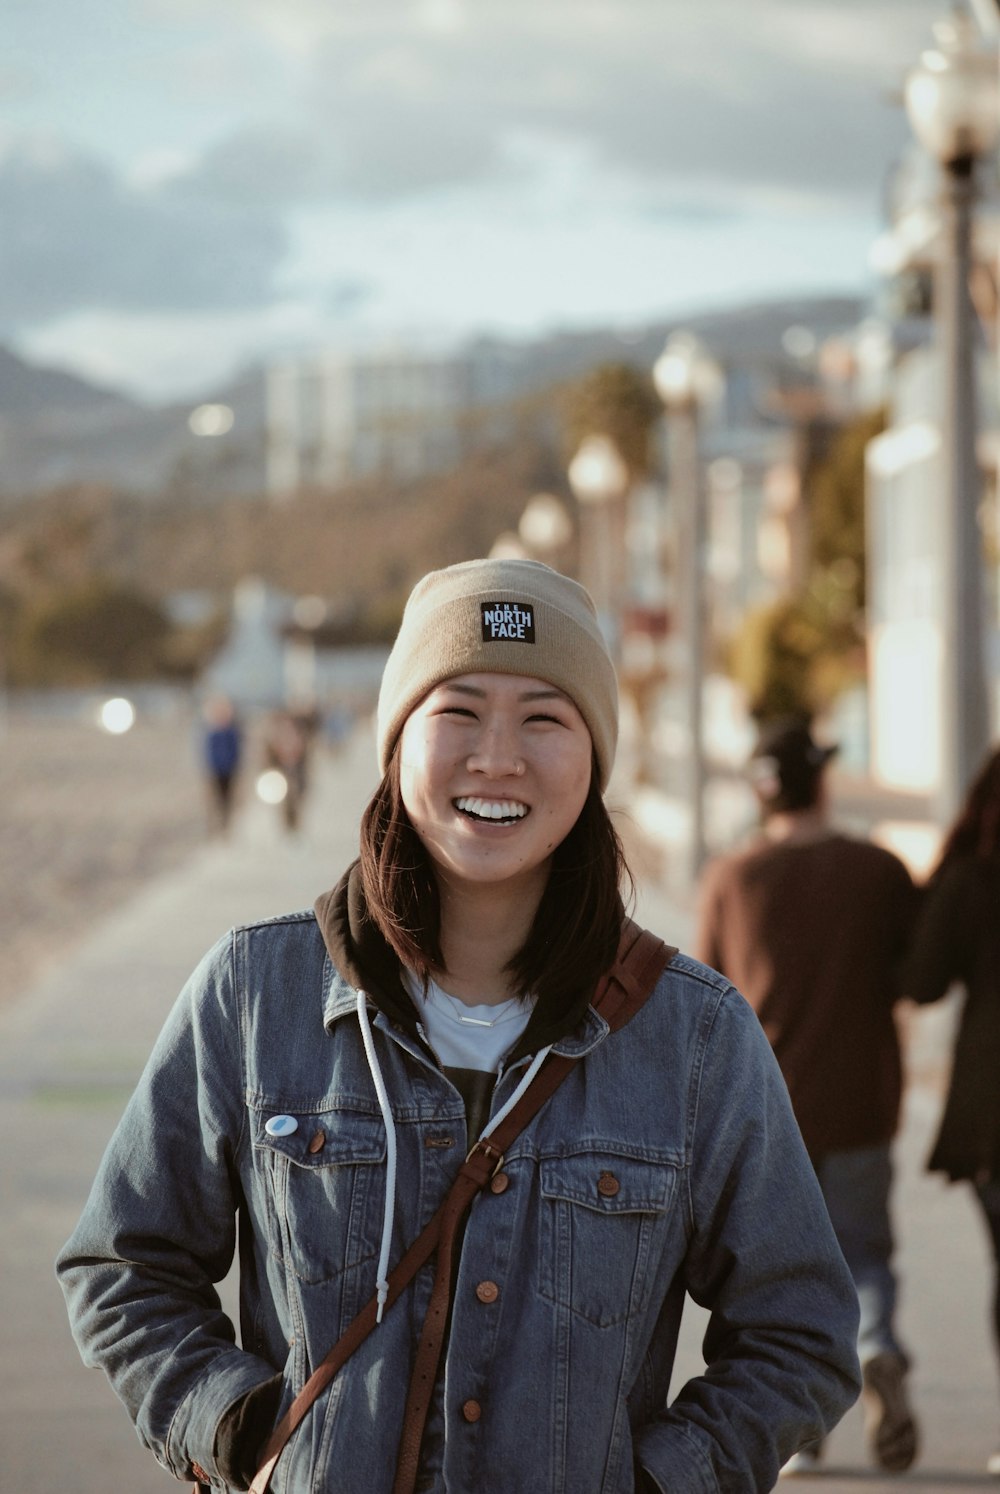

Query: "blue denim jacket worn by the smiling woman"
<box><xmin>58</xmin><ymin>890</ymin><xmax>858</xmax><ymax>1494</ymax></box>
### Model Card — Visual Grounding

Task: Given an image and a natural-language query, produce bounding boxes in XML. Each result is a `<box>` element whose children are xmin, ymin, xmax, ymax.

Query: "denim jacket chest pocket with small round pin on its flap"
<box><xmin>254</xmin><ymin>1110</ymin><xmax>386</xmax><ymax>1282</ymax></box>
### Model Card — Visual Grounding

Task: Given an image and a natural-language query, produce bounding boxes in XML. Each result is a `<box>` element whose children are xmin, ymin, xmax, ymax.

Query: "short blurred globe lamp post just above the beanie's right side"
<box><xmin>568</xmin><ymin>435</ymin><xmax>628</xmax><ymax>659</ymax></box>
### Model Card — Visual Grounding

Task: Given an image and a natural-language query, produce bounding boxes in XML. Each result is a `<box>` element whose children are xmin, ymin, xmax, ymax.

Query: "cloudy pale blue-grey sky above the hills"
<box><xmin>0</xmin><ymin>0</ymin><xmax>948</xmax><ymax>399</ymax></box>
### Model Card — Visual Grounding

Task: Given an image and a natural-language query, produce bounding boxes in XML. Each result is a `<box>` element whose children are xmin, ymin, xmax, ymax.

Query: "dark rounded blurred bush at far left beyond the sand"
<box><xmin>10</xmin><ymin>578</ymin><xmax>170</xmax><ymax>684</ymax></box>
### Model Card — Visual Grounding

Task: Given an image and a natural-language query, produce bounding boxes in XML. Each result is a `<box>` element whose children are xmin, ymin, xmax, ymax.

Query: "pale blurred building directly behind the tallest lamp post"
<box><xmin>865</xmin><ymin>148</ymin><xmax>1000</xmax><ymax>793</ymax></box>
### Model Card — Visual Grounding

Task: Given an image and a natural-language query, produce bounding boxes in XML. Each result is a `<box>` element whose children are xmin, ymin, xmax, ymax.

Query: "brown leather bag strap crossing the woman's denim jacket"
<box><xmin>250</xmin><ymin>919</ymin><xmax>677</xmax><ymax>1494</ymax></box>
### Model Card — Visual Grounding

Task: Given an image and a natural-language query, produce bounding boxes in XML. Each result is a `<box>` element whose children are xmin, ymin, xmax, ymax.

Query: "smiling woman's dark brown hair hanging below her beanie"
<box><xmin>360</xmin><ymin>748</ymin><xmax>634</xmax><ymax>1019</ymax></box>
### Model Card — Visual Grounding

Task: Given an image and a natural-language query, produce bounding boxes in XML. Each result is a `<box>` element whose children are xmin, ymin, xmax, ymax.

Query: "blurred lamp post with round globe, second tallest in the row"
<box><xmin>653</xmin><ymin>333</ymin><xmax>720</xmax><ymax>881</ymax></box>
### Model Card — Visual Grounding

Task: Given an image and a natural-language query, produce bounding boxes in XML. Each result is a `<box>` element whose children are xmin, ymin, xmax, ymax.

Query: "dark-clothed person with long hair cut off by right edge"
<box><xmin>904</xmin><ymin>750</ymin><xmax>1000</xmax><ymax>1476</ymax></box>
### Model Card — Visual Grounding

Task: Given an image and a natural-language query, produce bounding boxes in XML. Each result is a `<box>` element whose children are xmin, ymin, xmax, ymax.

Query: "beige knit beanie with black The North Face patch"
<box><xmin>378</xmin><ymin>560</ymin><xmax>617</xmax><ymax>789</ymax></box>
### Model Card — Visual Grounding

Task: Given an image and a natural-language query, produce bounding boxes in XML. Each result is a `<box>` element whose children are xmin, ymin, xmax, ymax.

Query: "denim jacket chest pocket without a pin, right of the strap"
<box><xmin>538</xmin><ymin>1150</ymin><xmax>676</xmax><ymax>1328</ymax></box>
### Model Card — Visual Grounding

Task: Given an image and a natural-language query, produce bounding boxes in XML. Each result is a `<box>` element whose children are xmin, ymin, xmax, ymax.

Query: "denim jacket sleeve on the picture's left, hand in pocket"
<box><xmin>57</xmin><ymin>935</ymin><xmax>278</xmax><ymax>1479</ymax></box>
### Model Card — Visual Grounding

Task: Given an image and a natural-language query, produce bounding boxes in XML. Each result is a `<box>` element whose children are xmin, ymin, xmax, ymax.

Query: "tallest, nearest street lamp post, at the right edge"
<box><xmin>906</xmin><ymin>13</ymin><xmax>1000</xmax><ymax>823</ymax></box>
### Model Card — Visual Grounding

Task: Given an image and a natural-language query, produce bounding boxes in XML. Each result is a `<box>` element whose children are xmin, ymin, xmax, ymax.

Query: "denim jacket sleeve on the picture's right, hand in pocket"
<box><xmin>637</xmin><ymin>988</ymin><xmax>861</xmax><ymax>1494</ymax></box>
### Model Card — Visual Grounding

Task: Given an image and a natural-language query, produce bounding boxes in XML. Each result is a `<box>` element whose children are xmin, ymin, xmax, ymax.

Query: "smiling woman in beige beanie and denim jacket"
<box><xmin>58</xmin><ymin>560</ymin><xmax>859</xmax><ymax>1494</ymax></box>
